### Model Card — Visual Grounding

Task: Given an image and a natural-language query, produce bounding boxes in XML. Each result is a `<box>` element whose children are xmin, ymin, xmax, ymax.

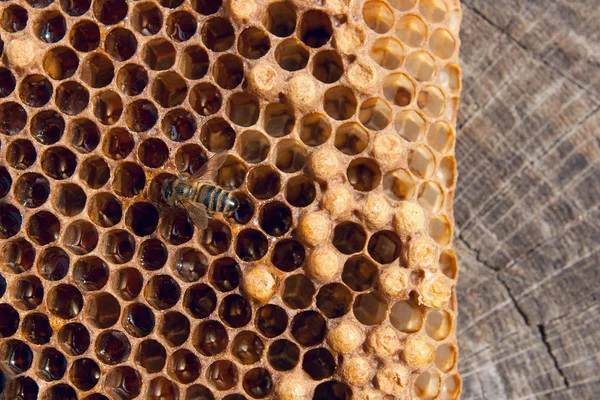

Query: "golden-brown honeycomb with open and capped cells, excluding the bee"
<box><xmin>0</xmin><ymin>0</ymin><xmax>461</xmax><ymax>400</ymax></box>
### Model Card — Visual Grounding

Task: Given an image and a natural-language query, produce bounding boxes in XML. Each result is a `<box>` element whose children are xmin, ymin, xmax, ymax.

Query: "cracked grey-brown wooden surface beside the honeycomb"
<box><xmin>455</xmin><ymin>0</ymin><xmax>600</xmax><ymax>400</ymax></box>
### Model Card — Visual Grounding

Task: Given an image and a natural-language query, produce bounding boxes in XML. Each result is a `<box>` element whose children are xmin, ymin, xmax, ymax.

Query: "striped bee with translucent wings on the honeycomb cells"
<box><xmin>160</xmin><ymin>153</ymin><xmax>240</xmax><ymax>229</ymax></box>
